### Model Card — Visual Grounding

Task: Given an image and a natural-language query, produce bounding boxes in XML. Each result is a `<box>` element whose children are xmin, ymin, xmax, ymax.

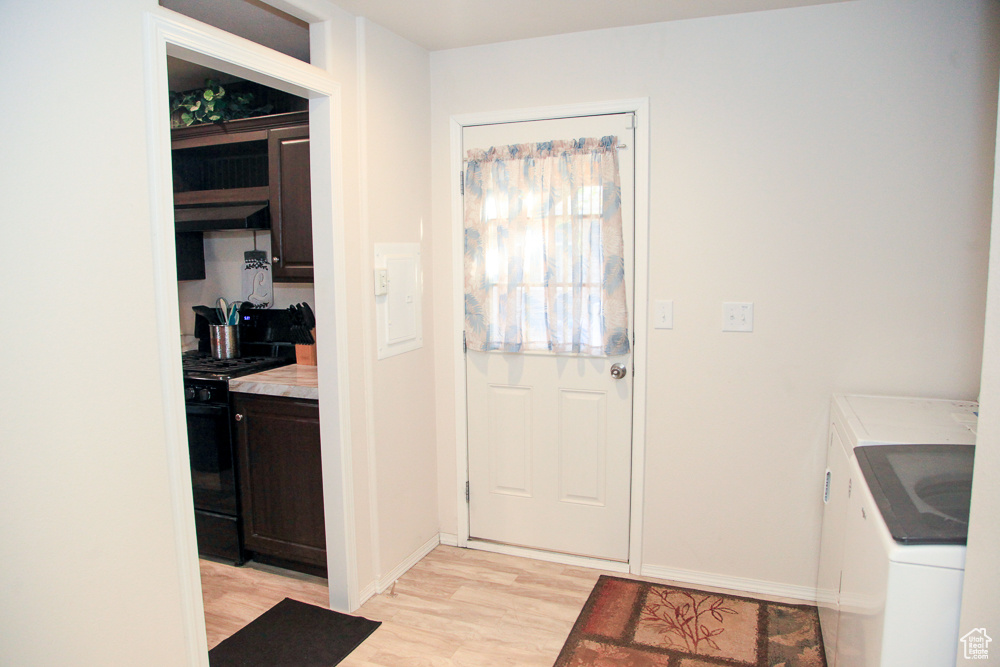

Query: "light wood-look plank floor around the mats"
<box><xmin>201</xmin><ymin>546</ymin><xmax>800</xmax><ymax>667</ymax></box>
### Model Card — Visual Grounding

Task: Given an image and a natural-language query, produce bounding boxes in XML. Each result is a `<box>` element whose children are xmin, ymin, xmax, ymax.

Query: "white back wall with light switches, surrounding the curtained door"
<box><xmin>431</xmin><ymin>0</ymin><xmax>1000</xmax><ymax>595</ymax></box>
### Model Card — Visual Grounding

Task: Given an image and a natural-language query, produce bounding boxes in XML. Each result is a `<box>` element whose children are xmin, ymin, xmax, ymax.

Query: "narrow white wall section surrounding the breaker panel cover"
<box><xmin>361</xmin><ymin>21</ymin><xmax>439</xmax><ymax>585</ymax></box>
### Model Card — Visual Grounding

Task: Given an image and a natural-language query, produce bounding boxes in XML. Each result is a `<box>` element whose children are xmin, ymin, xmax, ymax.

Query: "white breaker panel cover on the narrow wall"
<box><xmin>374</xmin><ymin>243</ymin><xmax>424</xmax><ymax>359</ymax></box>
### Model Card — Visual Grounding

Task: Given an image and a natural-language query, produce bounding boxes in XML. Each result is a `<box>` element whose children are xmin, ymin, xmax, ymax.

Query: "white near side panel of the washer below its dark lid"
<box><xmin>873</xmin><ymin>563</ymin><xmax>965</xmax><ymax>667</ymax></box>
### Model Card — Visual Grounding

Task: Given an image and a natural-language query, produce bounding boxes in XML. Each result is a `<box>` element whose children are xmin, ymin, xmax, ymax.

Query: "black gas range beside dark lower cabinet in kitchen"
<box><xmin>181</xmin><ymin>346</ymin><xmax>295</xmax><ymax>565</ymax></box>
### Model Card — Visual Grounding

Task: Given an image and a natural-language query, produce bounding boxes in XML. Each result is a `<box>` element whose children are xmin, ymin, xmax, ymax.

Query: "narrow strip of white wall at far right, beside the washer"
<box><xmin>958</xmin><ymin>78</ymin><xmax>1000</xmax><ymax>664</ymax></box>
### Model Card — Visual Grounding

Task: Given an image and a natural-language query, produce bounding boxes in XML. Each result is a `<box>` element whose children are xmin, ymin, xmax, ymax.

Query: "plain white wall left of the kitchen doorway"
<box><xmin>0</xmin><ymin>0</ymin><xmax>193</xmax><ymax>667</ymax></box>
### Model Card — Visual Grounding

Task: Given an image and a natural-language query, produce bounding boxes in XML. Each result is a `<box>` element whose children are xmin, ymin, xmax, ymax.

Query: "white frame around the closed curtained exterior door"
<box><xmin>449</xmin><ymin>98</ymin><xmax>649</xmax><ymax>574</ymax></box>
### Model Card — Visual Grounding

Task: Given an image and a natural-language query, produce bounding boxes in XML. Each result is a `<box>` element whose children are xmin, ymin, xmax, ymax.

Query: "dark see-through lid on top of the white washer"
<box><xmin>854</xmin><ymin>445</ymin><xmax>976</xmax><ymax>544</ymax></box>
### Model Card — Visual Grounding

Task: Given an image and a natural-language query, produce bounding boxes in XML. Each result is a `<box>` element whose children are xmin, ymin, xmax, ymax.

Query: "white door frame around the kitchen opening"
<box><xmin>143</xmin><ymin>5</ymin><xmax>360</xmax><ymax>667</ymax></box>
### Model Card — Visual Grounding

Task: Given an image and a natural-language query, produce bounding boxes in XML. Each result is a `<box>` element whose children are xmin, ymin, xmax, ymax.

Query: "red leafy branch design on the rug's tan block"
<box><xmin>642</xmin><ymin>588</ymin><xmax>738</xmax><ymax>653</ymax></box>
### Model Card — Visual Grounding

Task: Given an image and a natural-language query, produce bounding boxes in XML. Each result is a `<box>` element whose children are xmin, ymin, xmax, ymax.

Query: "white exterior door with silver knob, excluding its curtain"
<box><xmin>463</xmin><ymin>114</ymin><xmax>635</xmax><ymax>562</ymax></box>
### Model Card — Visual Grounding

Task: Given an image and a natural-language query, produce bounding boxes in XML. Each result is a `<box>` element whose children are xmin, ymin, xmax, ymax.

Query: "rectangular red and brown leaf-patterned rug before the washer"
<box><xmin>554</xmin><ymin>576</ymin><xmax>826</xmax><ymax>667</ymax></box>
